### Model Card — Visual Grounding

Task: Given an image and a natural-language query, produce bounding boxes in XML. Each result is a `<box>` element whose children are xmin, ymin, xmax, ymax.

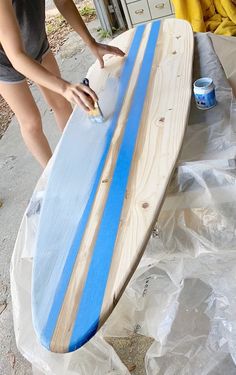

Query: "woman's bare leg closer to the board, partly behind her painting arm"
<box><xmin>38</xmin><ymin>51</ymin><xmax>72</xmax><ymax>131</ymax></box>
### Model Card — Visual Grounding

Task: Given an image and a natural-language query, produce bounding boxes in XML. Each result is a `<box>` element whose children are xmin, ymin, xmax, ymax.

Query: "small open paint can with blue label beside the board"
<box><xmin>193</xmin><ymin>77</ymin><xmax>216</xmax><ymax>110</ymax></box>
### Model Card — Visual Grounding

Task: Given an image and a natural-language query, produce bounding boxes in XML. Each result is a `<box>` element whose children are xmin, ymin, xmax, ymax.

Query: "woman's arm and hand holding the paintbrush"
<box><xmin>0</xmin><ymin>0</ymin><xmax>97</xmax><ymax>110</ymax></box>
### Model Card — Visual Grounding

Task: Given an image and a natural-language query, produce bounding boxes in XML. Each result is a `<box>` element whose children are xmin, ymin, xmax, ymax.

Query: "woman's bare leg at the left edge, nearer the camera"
<box><xmin>0</xmin><ymin>82</ymin><xmax>52</xmax><ymax>168</ymax></box>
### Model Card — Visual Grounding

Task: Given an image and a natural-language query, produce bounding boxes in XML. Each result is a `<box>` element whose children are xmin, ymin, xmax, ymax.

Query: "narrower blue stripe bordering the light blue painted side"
<box><xmin>40</xmin><ymin>25</ymin><xmax>145</xmax><ymax>349</ymax></box>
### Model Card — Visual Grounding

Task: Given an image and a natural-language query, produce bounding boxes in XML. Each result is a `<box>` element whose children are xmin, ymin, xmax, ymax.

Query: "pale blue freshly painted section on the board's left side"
<box><xmin>32</xmin><ymin>79</ymin><xmax>119</xmax><ymax>346</ymax></box>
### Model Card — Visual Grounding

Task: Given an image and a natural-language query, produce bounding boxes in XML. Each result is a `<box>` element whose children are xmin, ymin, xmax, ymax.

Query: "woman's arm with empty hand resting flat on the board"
<box><xmin>54</xmin><ymin>0</ymin><xmax>125</xmax><ymax>68</ymax></box>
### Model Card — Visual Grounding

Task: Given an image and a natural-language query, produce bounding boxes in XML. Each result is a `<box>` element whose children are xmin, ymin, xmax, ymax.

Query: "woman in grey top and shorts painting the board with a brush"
<box><xmin>0</xmin><ymin>0</ymin><xmax>124</xmax><ymax>168</ymax></box>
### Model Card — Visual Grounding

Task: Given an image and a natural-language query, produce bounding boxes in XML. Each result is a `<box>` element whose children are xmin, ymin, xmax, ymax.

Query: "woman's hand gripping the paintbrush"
<box><xmin>62</xmin><ymin>82</ymin><xmax>98</xmax><ymax>112</ymax></box>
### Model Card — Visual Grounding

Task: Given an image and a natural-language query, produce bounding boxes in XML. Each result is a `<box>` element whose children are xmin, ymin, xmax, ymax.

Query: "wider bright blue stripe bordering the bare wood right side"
<box><xmin>69</xmin><ymin>22</ymin><xmax>160</xmax><ymax>351</ymax></box>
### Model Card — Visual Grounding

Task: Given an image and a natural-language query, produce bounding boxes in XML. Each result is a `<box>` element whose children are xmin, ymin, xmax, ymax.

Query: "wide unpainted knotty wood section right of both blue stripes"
<box><xmin>100</xmin><ymin>20</ymin><xmax>193</xmax><ymax>326</ymax></box>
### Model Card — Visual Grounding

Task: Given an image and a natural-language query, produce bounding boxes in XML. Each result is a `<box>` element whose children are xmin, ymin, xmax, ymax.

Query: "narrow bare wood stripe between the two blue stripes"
<box><xmin>50</xmin><ymin>25</ymin><xmax>150</xmax><ymax>352</ymax></box>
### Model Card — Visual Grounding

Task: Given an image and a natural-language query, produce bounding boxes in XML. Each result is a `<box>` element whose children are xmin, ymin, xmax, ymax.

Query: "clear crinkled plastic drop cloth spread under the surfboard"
<box><xmin>11</xmin><ymin>34</ymin><xmax>236</xmax><ymax>375</ymax></box>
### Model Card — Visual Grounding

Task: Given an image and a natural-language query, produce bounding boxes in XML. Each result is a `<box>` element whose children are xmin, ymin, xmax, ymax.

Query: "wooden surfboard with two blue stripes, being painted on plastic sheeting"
<box><xmin>32</xmin><ymin>19</ymin><xmax>193</xmax><ymax>353</ymax></box>
